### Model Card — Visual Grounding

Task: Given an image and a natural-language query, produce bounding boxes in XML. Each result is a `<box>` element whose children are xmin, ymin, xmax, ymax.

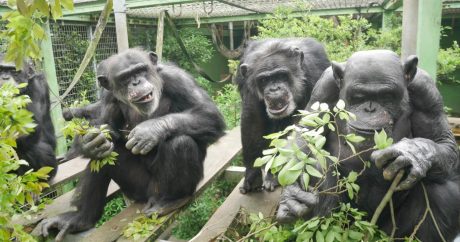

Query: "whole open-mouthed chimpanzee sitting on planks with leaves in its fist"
<box><xmin>42</xmin><ymin>49</ymin><xmax>225</xmax><ymax>240</ymax></box>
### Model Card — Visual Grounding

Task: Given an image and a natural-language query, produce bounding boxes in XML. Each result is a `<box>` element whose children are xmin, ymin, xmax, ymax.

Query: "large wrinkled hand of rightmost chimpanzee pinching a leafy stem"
<box><xmin>371</xmin><ymin>138</ymin><xmax>436</xmax><ymax>191</ymax></box>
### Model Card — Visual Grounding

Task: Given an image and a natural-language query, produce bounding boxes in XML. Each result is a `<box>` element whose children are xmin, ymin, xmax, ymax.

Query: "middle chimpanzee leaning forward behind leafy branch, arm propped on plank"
<box><xmin>237</xmin><ymin>38</ymin><xmax>330</xmax><ymax>193</ymax></box>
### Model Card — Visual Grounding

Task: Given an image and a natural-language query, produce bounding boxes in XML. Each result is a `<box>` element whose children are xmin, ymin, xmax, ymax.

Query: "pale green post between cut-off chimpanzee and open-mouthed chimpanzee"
<box><xmin>41</xmin><ymin>22</ymin><xmax>67</xmax><ymax>155</ymax></box>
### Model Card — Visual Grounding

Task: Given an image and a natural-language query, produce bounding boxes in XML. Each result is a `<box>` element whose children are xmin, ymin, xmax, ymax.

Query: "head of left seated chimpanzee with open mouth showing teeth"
<box><xmin>98</xmin><ymin>49</ymin><xmax>163</xmax><ymax>116</ymax></box>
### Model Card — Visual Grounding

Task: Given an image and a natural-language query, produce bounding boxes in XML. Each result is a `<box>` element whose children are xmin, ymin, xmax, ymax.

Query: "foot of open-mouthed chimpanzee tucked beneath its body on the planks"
<box><xmin>142</xmin><ymin>196</ymin><xmax>192</xmax><ymax>217</ymax></box>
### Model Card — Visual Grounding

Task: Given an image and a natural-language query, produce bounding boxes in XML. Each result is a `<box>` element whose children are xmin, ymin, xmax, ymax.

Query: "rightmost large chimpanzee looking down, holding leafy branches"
<box><xmin>277</xmin><ymin>50</ymin><xmax>460</xmax><ymax>241</ymax></box>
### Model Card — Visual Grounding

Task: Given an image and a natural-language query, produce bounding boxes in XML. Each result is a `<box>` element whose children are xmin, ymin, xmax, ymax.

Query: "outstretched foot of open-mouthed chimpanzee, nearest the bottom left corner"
<box><xmin>40</xmin><ymin>212</ymin><xmax>94</xmax><ymax>242</ymax></box>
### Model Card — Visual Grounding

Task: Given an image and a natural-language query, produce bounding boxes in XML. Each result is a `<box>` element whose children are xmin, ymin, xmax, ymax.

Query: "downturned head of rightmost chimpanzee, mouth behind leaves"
<box><xmin>332</xmin><ymin>50</ymin><xmax>417</xmax><ymax>136</ymax></box>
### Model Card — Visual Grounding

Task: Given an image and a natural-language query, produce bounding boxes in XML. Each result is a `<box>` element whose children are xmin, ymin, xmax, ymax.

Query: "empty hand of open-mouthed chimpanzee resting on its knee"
<box><xmin>126</xmin><ymin>120</ymin><xmax>167</xmax><ymax>155</ymax></box>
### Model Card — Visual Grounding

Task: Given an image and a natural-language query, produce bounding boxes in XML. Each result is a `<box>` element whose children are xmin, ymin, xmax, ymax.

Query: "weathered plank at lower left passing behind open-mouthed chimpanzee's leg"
<box><xmin>13</xmin><ymin>181</ymin><xmax>119</xmax><ymax>228</ymax></box>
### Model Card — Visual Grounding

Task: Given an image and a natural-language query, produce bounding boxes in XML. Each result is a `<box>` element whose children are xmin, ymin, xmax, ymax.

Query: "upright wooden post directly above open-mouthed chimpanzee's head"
<box><xmin>113</xmin><ymin>0</ymin><xmax>129</xmax><ymax>52</ymax></box>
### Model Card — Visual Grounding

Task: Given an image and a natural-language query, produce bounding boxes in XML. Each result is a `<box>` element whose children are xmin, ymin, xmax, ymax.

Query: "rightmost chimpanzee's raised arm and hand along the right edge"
<box><xmin>372</xmin><ymin>69</ymin><xmax>458</xmax><ymax>190</ymax></box>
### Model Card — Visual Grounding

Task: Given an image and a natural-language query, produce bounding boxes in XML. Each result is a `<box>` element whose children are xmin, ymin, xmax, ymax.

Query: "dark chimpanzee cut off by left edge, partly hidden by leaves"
<box><xmin>0</xmin><ymin>54</ymin><xmax>57</xmax><ymax>179</ymax></box>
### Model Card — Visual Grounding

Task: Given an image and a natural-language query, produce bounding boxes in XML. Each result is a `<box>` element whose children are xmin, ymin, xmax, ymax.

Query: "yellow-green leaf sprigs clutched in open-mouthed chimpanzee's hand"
<box><xmin>62</xmin><ymin>118</ymin><xmax>118</xmax><ymax>172</ymax></box>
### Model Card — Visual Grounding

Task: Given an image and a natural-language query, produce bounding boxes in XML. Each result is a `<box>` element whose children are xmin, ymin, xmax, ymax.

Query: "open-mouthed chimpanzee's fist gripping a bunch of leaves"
<box><xmin>81</xmin><ymin>132</ymin><xmax>113</xmax><ymax>160</ymax></box>
